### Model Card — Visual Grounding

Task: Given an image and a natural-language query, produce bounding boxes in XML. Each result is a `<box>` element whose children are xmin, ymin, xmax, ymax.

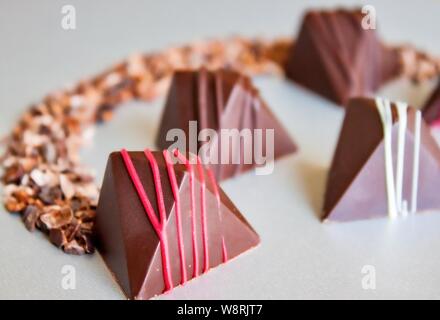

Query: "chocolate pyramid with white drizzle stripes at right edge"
<box><xmin>323</xmin><ymin>98</ymin><xmax>440</xmax><ymax>221</ymax></box>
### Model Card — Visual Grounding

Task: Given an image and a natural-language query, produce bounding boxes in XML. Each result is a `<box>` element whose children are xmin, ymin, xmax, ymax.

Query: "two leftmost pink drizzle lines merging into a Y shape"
<box><xmin>121</xmin><ymin>149</ymin><xmax>173</xmax><ymax>291</ymax></box>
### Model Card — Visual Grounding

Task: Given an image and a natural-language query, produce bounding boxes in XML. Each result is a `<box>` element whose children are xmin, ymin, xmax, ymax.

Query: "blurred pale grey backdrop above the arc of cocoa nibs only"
<box><xmin>0</xmin><ymin>0</ymin><xmax>440</xmax><ymax>134</ymax></box>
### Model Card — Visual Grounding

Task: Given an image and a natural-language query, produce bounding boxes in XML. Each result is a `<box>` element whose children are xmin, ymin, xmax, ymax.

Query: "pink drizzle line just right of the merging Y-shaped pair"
<box><xmin>163</xmin><ymin>150</ymin><xmax>187</xmax><ymax>284</ymax></box>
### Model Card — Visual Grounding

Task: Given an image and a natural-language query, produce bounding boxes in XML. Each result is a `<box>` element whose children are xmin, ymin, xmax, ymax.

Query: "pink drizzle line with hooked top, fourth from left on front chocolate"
<box><xmin>174</xmin><ymin>149</ymin><xmax>199</xmax><ymax>278</ymax></box>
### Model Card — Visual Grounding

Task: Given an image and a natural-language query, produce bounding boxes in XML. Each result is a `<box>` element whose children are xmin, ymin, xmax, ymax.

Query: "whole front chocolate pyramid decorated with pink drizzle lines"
<box><xmin>96</xmin><ymin>150</ymin><xmax>259</xmax><ymax>299</ymax></box>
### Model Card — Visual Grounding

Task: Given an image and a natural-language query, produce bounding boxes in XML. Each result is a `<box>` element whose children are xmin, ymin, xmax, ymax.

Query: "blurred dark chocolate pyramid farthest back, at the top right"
<box><xmin>286</xmin><ymin>9</ymin><xmax>399</xmax><ymax>105</ymax></box>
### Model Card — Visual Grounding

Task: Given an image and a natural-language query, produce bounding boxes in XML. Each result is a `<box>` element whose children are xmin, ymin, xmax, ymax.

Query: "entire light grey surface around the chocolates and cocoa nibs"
<box><xmin>0</xmin><ymin>0</ymin><xmax>440</xmax><ymax>299</ymax></box>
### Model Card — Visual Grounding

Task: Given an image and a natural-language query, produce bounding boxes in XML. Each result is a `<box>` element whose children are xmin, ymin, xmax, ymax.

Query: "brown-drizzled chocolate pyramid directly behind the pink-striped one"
<box><xmin>156</xmin><ymin>68</ymin><xmax>296</xmax><ymax>180</ymax></box>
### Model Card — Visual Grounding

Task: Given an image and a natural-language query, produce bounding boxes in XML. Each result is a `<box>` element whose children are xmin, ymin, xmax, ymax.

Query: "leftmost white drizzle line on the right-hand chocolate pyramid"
<box><xmin>376</xmin><ymin>98</ymin><xmax>397</xmax><ymax>219</ymax></box>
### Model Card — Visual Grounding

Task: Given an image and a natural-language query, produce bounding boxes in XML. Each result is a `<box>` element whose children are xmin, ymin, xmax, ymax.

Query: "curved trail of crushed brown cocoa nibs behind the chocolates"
<box><xmin>0</xmin><ymin>37</ymin><xmax>440</xmax><ymax>254</ymax></box>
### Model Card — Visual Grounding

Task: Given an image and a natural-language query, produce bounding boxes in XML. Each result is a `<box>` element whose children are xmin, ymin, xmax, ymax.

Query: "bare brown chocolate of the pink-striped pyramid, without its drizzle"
<box><xmin>96</xmin><ymin>152</ymin><xmax>260</xmax><ymax>299</ymax></box>
